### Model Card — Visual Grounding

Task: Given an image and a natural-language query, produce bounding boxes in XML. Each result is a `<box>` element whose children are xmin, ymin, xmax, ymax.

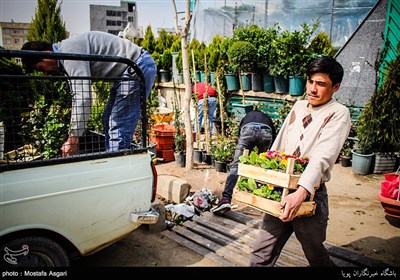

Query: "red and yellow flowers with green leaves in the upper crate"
<box><xmin>239</xmin><ymin>151</ymin><xmax>309</xmax><ymax>174</ymax></box>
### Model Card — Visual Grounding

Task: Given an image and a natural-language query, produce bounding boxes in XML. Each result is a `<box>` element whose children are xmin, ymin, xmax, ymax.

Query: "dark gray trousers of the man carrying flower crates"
<box><xmin>250</xmin><ymin>184</ymin><xmax>334</xmax><ymax>267</ymax></box>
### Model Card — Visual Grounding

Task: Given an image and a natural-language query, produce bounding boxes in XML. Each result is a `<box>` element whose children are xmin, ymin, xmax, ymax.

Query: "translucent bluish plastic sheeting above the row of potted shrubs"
<box><xmin>190</xmin><ymin>0</ymin><xmax>378</xmax><ymax>47</ymax></box>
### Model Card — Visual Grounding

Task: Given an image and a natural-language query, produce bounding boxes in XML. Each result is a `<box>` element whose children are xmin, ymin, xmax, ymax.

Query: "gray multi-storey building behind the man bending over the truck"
<box><xmin>90</xmin><ymin>0</ymin><xmax>138</xmax><ymax>36</ymax></box>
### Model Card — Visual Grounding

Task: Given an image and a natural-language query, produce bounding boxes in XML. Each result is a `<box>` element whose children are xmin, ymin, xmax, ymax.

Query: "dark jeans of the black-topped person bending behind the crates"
<box><xmin>222</xmin><ymin>123</ymin><xmax>273</xmax><ymax>200</ymax></box>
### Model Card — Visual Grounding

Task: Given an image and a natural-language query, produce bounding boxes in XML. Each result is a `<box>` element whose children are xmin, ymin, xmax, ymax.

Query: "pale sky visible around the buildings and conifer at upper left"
<box><xmin>0</xmin><ymin>0</ymin><xmax>185</xmax><ymax>35</ymax></box>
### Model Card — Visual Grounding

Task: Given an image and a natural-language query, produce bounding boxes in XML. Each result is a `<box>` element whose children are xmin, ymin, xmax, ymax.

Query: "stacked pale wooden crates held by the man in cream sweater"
<box><xmin>233</xmin><ymin>154</ymin><xmax>316</xmax><ymax>217</ymax></box>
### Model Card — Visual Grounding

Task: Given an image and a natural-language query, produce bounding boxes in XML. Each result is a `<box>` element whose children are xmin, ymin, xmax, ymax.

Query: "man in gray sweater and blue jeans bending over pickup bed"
<box><xmin>22</xmin><ymin>31</ymin><xmax>157</xmax><ymax>157</ymax></box>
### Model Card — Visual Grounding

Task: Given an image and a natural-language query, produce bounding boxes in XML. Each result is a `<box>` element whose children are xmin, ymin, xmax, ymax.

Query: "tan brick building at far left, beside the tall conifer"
<box><xmin>0</xmin><ymin>21</ymin><xmax>30</xmax><ymax>50</ymax></box>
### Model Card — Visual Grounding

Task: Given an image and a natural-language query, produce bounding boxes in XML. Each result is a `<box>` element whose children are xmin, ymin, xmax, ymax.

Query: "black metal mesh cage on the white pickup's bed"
<box><xmin>0</xmin><ymin>50</ymin><xmax>147</xmax><ymax>171</ymax></box>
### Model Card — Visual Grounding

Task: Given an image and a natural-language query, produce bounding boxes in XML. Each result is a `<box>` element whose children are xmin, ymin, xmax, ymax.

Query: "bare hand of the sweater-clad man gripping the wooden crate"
<box><xmin>279</xmin><ymin>186</ymin><xmax>308</xmax><ymax>222</ymax></box>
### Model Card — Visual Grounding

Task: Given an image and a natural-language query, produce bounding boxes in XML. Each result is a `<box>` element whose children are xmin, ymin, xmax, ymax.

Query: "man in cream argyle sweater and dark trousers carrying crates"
<box><xmin>250</xmin><ymin>56</ymin><xmax>351</xmax><ymax>266</ymax></box>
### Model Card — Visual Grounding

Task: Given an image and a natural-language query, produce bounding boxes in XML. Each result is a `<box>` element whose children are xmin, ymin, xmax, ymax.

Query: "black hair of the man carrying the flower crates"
<box><xmin>307</xmin><ymin>56</ymin><xmax>344</xmax><ymax>86</ymax></box>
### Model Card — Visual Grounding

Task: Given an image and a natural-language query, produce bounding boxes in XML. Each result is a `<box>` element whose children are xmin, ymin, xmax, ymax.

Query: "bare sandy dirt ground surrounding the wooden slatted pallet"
<box><xmin>72</xmin><ymin>162</ymin><xmax>400</xmax><ymax>268</ymax></box>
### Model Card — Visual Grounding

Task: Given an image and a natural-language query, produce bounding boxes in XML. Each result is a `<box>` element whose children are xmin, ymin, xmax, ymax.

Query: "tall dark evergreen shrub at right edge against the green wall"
<box><xmin>353</xmin><ymin>41</ymin><xmax>400</xmax><ymax>173</ymax></box>
